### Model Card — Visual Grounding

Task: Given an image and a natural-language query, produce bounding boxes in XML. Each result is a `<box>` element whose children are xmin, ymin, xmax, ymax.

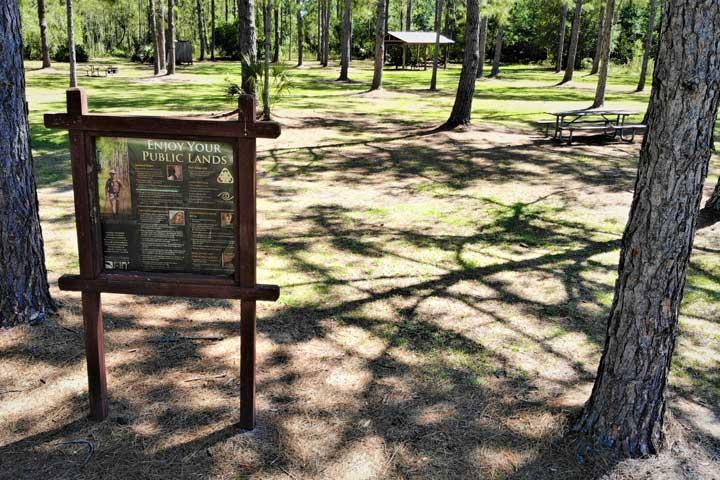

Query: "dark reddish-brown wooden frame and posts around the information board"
<box><xmin>44</xmin><ymin>88</ymin><xmax>280</xmax><ymax>430</ymax></box>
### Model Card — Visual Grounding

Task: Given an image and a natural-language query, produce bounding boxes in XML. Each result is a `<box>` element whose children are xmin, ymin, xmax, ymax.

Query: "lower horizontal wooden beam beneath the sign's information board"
<box><xmin>58</xmin><ymin>273</ymin><xmax>280</xmax><ymax>301</ymax></box>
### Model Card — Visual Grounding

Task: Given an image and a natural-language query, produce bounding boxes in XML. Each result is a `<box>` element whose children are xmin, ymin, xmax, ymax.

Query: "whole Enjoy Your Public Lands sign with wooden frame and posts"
<box><xmin>45</xmin><ymin>88</ymin><xmax>280</xmax><ymax>429</ymax></box>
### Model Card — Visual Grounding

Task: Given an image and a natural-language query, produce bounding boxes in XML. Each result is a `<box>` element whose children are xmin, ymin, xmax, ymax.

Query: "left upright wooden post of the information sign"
<box><xmin>67</xmin><ymin>88</ymin><xmax>108</xmax><ymax>421</ymax></box>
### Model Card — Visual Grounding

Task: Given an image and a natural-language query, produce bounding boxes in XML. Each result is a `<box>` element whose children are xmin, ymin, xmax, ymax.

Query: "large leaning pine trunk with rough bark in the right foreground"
<box><xmin>576</xmin><ymin>0</ymin><xmax>720</xmax><ymax>456</ymax></box>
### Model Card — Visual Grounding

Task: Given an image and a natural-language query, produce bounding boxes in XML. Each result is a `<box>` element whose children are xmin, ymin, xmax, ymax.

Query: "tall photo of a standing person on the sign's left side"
<box><xmin>95</xmin><ymin>137</ymin><xmax>132</xmax><ymax>218</ymax></box>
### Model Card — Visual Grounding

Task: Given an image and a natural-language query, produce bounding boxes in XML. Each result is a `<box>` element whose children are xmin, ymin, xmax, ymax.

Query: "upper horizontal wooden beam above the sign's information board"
<box><xmin>45</xmin><ymin>113</ymin><xmax>280</xmax><ymax>138</ymax></box>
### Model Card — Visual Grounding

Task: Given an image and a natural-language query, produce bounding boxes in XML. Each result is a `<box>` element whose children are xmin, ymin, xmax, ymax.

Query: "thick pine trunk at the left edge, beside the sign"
<box><xmin>0</xmin><ymin>2</ymin><xmax>54</xmax><ymax>327</ymax></box>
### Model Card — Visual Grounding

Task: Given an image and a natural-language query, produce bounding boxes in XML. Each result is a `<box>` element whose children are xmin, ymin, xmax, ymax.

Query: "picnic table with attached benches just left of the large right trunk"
<box><xmin>538</xmin><ymin>108</ymin><xmax>646</xmax><ymax>144</ymax></box>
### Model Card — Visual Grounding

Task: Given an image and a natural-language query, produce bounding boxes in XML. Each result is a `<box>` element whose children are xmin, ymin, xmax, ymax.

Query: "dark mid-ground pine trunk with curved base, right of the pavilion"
<box><xmin>441</xmin><ymin>0</ymin><xmax>480</xmax><ymax>129</ymax></box>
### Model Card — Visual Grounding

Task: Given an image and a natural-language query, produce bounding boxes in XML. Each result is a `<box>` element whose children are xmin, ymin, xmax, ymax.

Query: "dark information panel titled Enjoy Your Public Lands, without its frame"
<box><xmin>95</xmin><ymin>137</ymin><xmax>235</xmax><ymax>274</ymax></box>
